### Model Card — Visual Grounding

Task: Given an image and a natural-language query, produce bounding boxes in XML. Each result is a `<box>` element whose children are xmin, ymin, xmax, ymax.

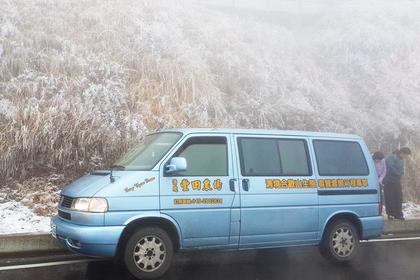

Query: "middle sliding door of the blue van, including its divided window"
<box><xmin>235</xmin><ymin>135</ymin><xmax>318</xmax><ymax>248</ymax></box>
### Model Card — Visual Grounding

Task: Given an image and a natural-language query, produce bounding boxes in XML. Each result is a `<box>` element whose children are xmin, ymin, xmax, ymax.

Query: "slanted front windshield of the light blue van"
<box><xmin>113</xmin><ymin>132</ymin><xmax>182</xmax><ymax>171</ymax></box>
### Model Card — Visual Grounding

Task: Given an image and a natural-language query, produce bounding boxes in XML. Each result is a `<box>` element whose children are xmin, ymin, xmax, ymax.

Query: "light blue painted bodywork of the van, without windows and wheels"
<box><xmin>51</xmin><ymin>129</ymin><xmax>383</xmax><ymax>257</ymax></box>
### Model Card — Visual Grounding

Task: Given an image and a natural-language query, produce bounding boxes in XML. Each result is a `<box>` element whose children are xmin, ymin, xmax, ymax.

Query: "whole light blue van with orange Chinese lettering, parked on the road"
<box><xmin>51</xmin><ymin>129</ymin><xmax>383</xmax><ymax>278</ymax></box>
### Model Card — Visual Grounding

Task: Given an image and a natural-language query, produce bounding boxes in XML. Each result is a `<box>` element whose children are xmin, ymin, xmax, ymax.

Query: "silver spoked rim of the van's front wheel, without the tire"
<box><xmin>133</xmin><ymin>235</ymin><xmax>166</xmax><ymax>272</ymax></box>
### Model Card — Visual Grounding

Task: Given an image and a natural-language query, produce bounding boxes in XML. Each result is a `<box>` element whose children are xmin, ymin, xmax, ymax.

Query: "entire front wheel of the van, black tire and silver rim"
<box><xmin>124</xmin><ymin>227</ymin><xmax>174</xmax><ymax>279</ymax></box>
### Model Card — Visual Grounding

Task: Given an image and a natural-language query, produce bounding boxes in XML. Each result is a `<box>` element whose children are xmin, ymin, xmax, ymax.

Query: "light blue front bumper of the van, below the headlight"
<box><xmin>51</xmin><ymin>215</ymin><xmax>124</xmax><ymax>257</ymax></box>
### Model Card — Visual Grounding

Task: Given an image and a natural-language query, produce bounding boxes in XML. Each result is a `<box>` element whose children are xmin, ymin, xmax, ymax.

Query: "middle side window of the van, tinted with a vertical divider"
<box><xmin>238</xmin><ymin>138</ymin><xmax>312</xmax><ymax>176</ymax></box>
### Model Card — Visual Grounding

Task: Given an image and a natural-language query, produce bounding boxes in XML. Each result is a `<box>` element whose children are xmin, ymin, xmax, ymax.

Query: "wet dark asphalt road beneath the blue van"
<box><xmin>0</xmin><ymin>237</ymin><xmax>420</xmax><ymax>280</ymax></box>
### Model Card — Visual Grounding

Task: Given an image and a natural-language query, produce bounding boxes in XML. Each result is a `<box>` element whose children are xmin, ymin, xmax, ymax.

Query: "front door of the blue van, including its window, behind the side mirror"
<box><xmin>160</xmin><ymin>134</ymin><xmax>239</xmax><ymax>249</ymax></box>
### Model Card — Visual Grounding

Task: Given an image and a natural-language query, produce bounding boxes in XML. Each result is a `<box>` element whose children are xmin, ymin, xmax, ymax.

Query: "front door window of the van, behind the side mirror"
<box><xmin>175</xmin><ymin>137</ymin><xmax>228</xmax><ymax>176</ymax></box>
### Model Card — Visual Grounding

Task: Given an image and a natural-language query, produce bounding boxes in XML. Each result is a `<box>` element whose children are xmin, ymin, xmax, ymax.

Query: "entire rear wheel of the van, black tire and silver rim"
<box><xmin>318</xmin><ymin>220</ymin><xmax>359</xmax><ymax>263</ymax></box>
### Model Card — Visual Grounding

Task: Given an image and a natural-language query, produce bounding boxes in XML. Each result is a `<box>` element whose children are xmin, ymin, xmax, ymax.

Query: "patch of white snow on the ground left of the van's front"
<box><xmin>0</xmin><ymin>201</ymin><xmax>50</xmax><ymax>234</ymax></box>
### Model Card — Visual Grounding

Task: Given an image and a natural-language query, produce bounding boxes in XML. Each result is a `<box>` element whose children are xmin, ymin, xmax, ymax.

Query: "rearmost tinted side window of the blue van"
<box><xmin>313</xmin><ymin>140</ymin><xmax>369</xmax><ymax>176</ymax></box>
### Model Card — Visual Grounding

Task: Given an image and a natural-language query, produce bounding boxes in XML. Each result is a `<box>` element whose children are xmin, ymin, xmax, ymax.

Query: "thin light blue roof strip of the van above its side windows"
<box><xmin>157</xmin><ymin>128</ymin><xmax>361</xmax><ymax>139</ymax></box>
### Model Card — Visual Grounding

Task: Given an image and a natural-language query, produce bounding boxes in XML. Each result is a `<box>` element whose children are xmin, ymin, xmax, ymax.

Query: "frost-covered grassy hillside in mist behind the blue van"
<box><xmin>0</xmin><ymin>0</ymin><xmax>420</xmax><ymax>232</ymax></box>
